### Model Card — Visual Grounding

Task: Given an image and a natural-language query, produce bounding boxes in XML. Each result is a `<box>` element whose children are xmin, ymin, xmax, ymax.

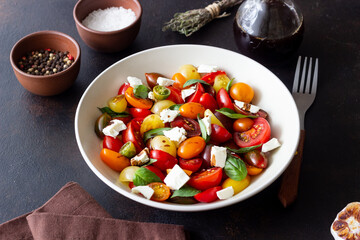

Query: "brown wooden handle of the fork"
<box><xmin>278</xmin><ymin>130</ymin><xmax>305</xmax><ymax>208</ymax></box>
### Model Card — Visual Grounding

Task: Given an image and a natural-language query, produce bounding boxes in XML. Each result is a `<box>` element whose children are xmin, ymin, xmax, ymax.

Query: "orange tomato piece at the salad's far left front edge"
<box><xmin>100</xmin><ymin>148</ymin><xmax>130</xmax><ymax>172</ymax></box>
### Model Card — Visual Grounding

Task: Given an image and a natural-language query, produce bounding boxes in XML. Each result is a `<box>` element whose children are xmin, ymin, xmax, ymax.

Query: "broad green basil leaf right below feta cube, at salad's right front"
<box><xmin>224</xmin><ymin>154</ymin><xmax>247</xmax><ymax>181</ymax></box>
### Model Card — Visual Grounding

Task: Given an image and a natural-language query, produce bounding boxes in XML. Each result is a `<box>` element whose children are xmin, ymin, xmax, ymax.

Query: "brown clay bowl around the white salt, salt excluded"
<box><xmin>73</xmin><ymin>0</ymin><xmax>142</xmax><ymax>52</ymax></box>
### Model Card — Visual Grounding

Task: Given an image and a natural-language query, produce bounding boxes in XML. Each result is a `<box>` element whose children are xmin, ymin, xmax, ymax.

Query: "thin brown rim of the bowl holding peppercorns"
<box><xmin>10</xmin><ymin>30</ymin><xmax>81</xmax><ymax>79</ymax></box>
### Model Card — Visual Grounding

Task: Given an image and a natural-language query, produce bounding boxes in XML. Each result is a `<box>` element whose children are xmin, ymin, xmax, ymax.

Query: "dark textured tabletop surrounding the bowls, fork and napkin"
<box><xmin>0</xmin><ymin>0</ymin><xmax>360</xmax><ymax>239</ymax></box>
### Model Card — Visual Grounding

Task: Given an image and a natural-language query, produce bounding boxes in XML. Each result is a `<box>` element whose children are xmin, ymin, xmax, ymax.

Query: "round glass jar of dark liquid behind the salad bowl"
<box><xmin>233</xmin><ymin>0</ymin><xmax>304</xmax><ymax>65</ymax></box>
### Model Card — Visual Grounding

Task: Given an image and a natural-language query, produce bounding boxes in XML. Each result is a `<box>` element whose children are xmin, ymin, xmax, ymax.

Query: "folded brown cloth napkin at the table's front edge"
<box><xmin>0</xmin><ymin>182</ymin><xmax>186</xmax><ymax>240</ymax></box>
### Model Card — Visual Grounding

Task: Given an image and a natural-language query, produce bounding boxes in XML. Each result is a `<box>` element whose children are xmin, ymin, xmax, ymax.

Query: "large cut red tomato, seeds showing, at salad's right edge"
<box><xmin>234</xmin><ymin>117</ymin><xmax>271</xmax><ymax>148</ymax></box>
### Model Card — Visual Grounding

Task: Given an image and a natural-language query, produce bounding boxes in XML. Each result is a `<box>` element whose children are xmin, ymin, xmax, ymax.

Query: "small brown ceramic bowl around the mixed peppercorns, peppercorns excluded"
<box><xmin>10</xmin><ymin>31</ymin><xmax>80</xmax><ymax>96</ymax></box>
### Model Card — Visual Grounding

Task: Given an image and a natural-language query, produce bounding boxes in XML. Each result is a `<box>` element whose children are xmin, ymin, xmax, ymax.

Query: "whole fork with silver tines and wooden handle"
<box><xmin>278</xmin><ymin>56</ymin><xmax>319</xmax><ymax>207</ymax></box>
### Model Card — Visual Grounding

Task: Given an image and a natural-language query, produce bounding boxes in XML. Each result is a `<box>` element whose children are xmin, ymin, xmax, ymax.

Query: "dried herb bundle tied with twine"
<box><xmin>162</xmin><ymin>0</ymin><xmax>243</xmax><ymax>37</ymax></box>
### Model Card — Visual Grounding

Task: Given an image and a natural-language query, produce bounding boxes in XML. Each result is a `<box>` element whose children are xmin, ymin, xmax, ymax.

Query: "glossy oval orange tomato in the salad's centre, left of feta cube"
<box><xmin>177</xmin><ymin>136</ymin><xmax>206</xmax><ymax>159</ymax></box>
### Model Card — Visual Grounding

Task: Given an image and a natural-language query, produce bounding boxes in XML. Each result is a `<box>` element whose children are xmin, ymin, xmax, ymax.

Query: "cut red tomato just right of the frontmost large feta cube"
<box><xmin>187</xmin><ymin>167</ymin><xmax>223</xmax><ymax>190</ymax></box>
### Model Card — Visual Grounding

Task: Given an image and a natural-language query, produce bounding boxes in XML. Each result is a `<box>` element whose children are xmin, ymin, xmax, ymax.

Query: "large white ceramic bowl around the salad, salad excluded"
<box><xmin>75</xmin><ymin>45</ymin><xmax>300</xmax><ymax>212</ymax></box>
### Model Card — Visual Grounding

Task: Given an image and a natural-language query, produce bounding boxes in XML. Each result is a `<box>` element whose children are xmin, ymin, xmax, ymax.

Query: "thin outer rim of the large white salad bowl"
<box><xmin>74</xmin><ymin>44</ymin><xmax>300</xmax><ymax>212</ymax></box>
